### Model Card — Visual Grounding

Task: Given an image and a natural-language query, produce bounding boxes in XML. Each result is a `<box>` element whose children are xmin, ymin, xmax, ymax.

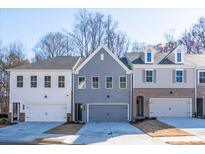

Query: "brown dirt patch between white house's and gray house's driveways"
<box><xmin>44</xmin><ymin>123</ymin><xmax>83</xmax><ymax>135</ymax></box>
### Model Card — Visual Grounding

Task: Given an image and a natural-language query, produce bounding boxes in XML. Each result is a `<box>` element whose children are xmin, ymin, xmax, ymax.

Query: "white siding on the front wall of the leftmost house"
<box><xmin>10</xmin><ymin>70</ymin><xmax>72</xmax><ymax>113</ymax></box>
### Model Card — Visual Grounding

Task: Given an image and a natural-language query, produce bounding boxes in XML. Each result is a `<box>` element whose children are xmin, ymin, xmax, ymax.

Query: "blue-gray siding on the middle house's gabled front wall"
<box><xmin>74</xmin><ymin>48</ymin><xmax>132</xmax><ymax>122</ymax></box>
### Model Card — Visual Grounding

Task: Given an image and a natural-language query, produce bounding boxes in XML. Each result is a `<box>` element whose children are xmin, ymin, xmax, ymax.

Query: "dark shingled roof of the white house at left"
<box><xmin>8</xmin><ymin>56</ymin><xmax>80</xmax><ymax>70</ymax></box>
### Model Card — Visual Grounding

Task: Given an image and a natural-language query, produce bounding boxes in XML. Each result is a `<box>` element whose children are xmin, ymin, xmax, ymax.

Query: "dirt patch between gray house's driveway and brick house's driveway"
<box><xmin>132</xmin><ymin>120</ymin><xmax>193</xmax><ymax>137</ymax></box>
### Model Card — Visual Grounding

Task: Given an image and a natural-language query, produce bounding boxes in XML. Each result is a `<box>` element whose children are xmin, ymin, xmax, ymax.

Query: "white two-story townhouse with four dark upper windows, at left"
<box><xmin>8</xmin><ymin>56</ymin><xmax>80</xmax><ymax>122</ymax></box>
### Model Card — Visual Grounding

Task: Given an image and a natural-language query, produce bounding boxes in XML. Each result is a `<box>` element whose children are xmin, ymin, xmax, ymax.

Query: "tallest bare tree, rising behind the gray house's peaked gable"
<box><xmin>67</xmin><ymin>9</ymin><xmax>129</xmax><ymax>57</ymax></box>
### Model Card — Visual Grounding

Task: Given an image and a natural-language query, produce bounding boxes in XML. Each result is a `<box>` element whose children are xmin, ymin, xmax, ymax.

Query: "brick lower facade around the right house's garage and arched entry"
<box><xmin>132</xmin><ymin>88</ymin><xmax>195</xmax><ymax>119</ymax></box>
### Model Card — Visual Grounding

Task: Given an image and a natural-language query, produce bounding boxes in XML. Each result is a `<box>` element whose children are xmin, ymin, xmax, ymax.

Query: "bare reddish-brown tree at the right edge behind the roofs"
<box><xmin>178</xmin><ymin>17</ymin><xmax>205</xmax><ymax>53</ymax></box>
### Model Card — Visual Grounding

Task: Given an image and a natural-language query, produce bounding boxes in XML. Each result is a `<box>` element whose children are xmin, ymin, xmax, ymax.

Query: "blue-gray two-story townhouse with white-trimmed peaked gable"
<box><xmin>73</xmin><ymin>46</ymin><xmax>132</xmax><ymax>122</ymax></box>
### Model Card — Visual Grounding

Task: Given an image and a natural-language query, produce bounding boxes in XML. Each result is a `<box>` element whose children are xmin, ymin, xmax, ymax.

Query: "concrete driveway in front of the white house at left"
<box><xmin>0</xmin><ymin>122</ymin><xmax>62</xmax><ymax>143</ymax></box>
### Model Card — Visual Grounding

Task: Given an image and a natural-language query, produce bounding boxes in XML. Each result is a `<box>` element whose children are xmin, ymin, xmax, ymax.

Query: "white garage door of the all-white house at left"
<box><xmin>25</xmin><ymin>104</ymin><xmax>67</xmax><ymax>122</ymax></box>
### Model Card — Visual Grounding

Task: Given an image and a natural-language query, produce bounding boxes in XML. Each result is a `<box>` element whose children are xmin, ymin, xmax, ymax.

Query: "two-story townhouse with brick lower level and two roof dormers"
<box><xmin>127</xmin><ymin>46</ymin><xmax>196</xmax><ymax>119</ymax></box>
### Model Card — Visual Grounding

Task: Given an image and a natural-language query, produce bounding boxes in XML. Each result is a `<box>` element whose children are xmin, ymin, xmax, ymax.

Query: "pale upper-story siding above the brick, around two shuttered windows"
<box><xmin>133</xmin><ymin>68</ymin><xmax>195</xmax><ymax>88</ymax></box>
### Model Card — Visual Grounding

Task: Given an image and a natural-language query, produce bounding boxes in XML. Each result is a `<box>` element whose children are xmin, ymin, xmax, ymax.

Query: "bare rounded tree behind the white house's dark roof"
<box><xmin>33</xmin><ymin>32</ymin><xmax>74</xmax><ymax>61</ymax></box>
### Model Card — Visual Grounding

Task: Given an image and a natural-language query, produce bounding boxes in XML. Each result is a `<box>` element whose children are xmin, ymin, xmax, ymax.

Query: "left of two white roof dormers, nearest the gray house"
<box><xmin>143</xmin><ymin>47</ymin><xmax>156</xmax><ymax>64</ymax></box>
